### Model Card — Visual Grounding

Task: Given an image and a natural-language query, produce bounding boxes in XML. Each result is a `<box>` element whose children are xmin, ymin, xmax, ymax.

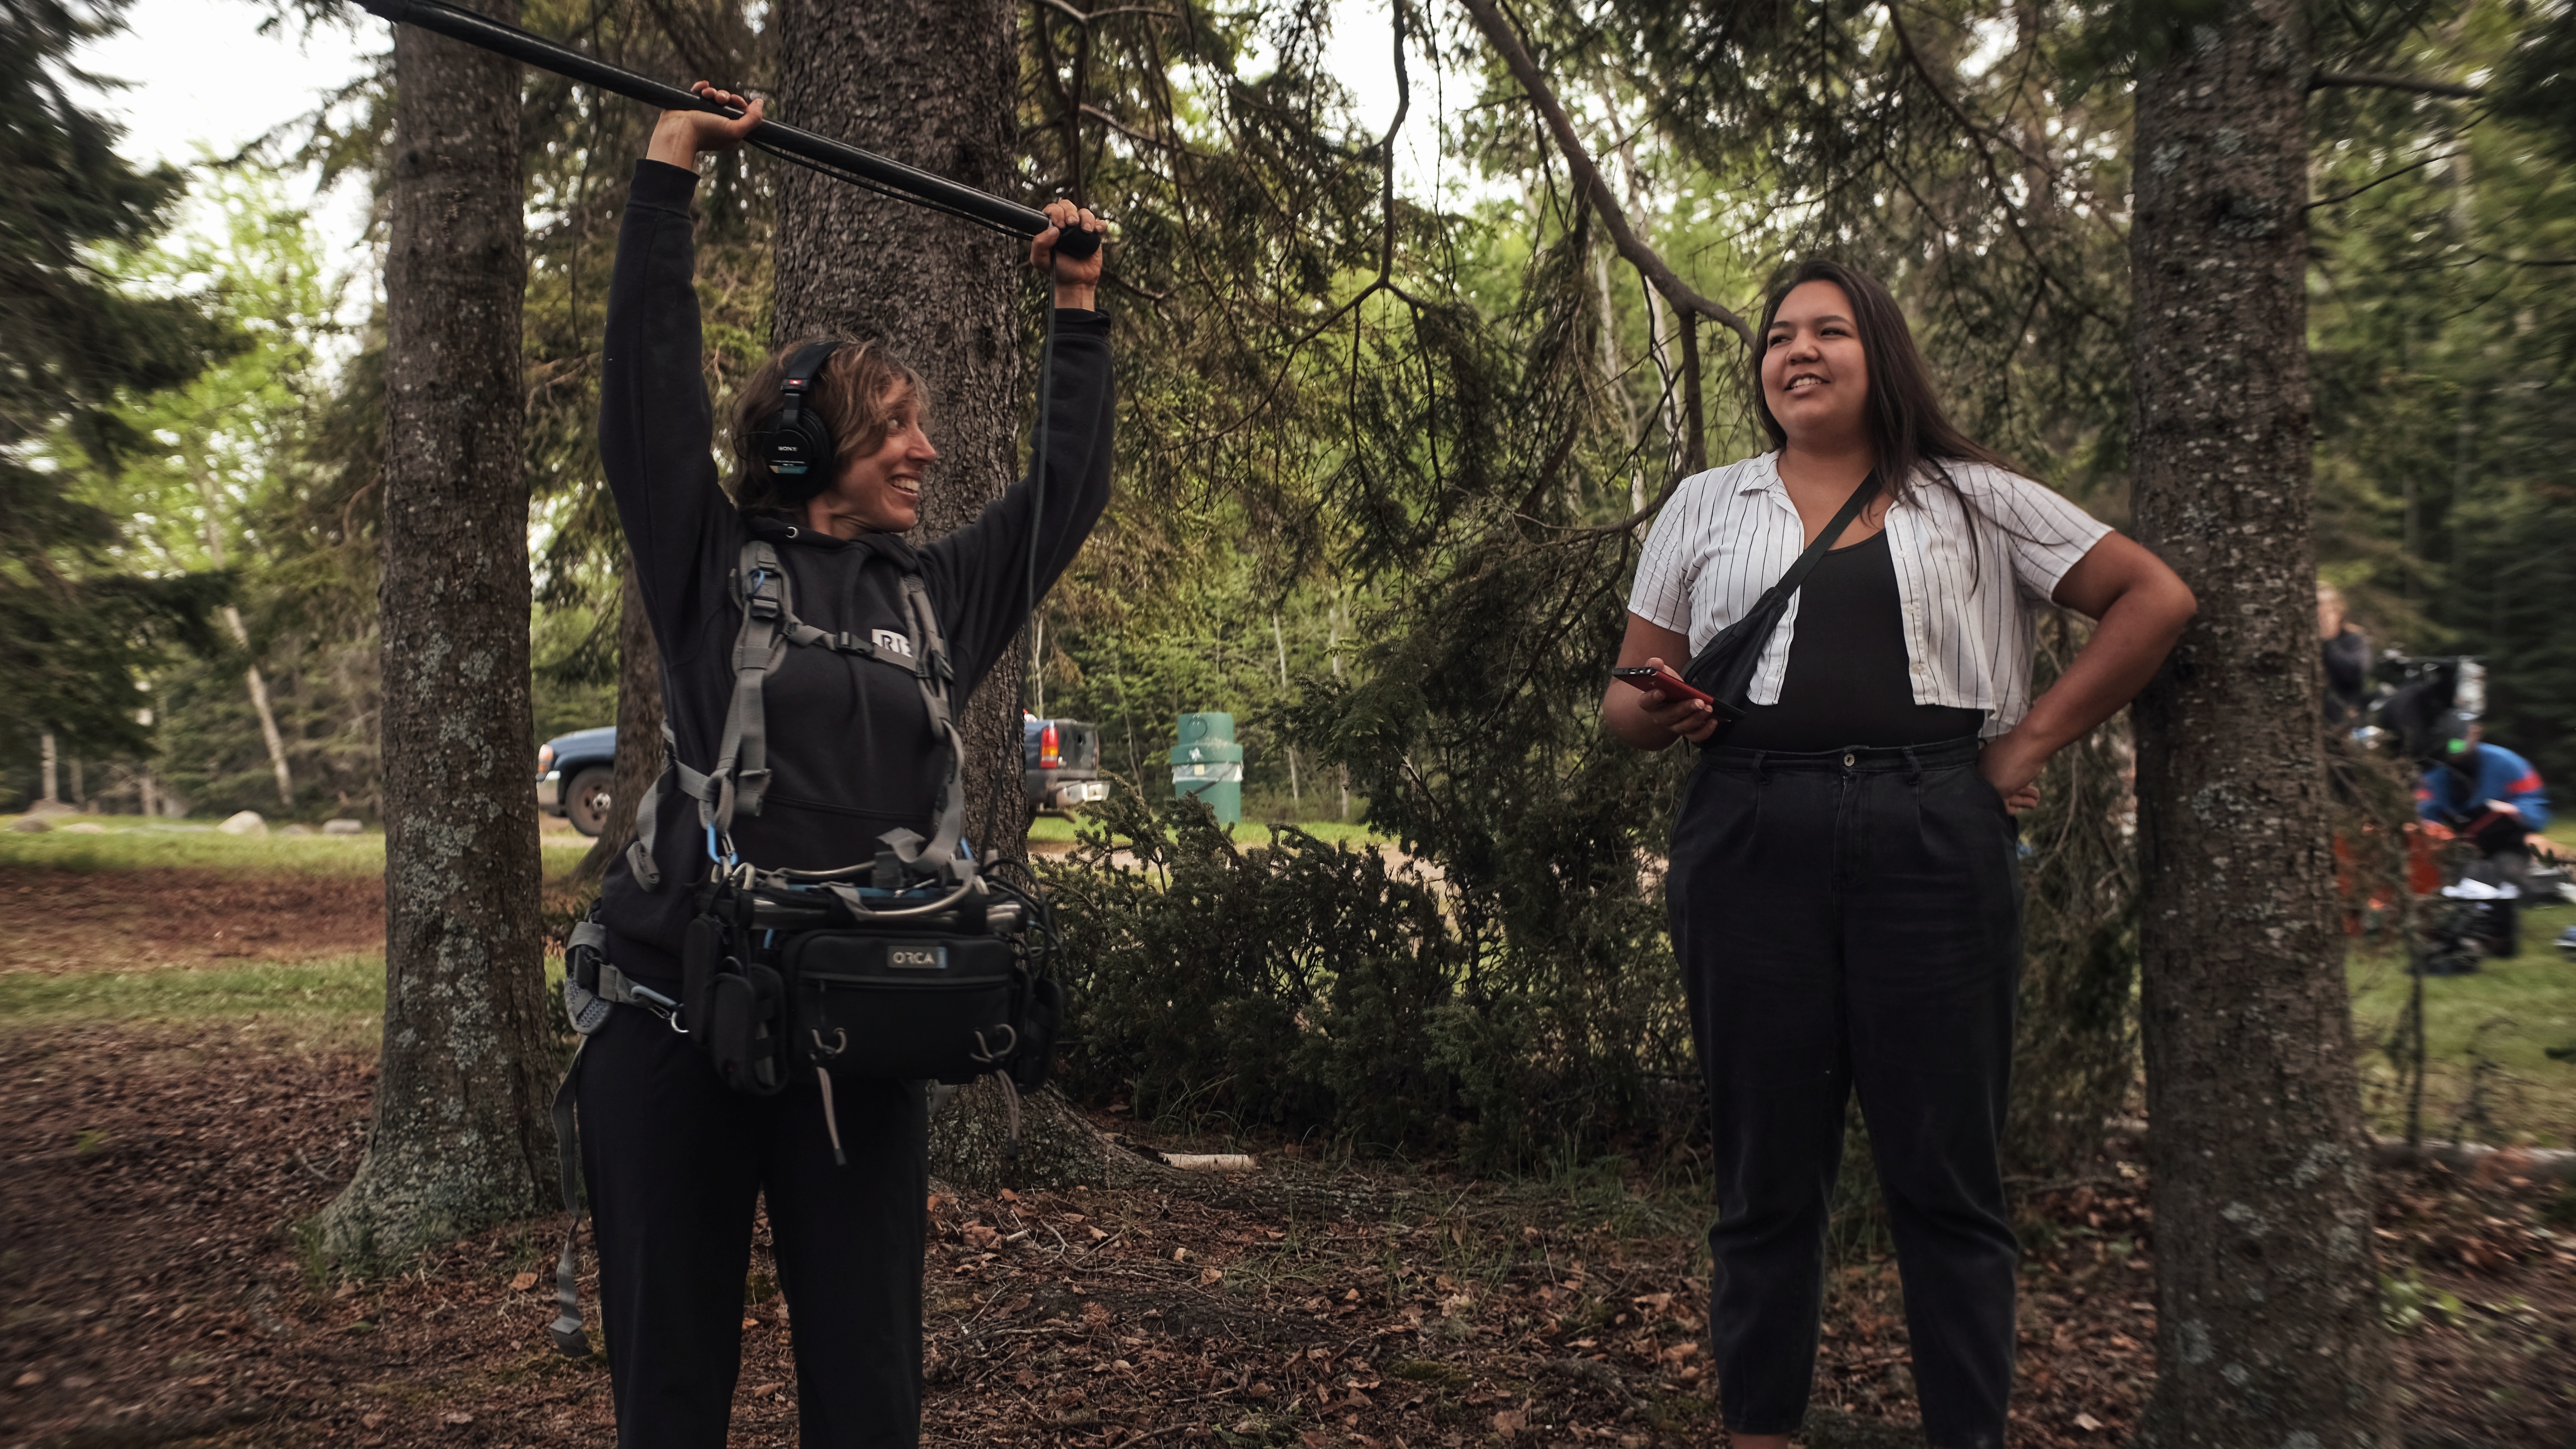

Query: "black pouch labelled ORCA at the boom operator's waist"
<box><xmin>783</xmin><ymin>932</ymin><xmax>1028</xmax><ymax>1084</ymax></box>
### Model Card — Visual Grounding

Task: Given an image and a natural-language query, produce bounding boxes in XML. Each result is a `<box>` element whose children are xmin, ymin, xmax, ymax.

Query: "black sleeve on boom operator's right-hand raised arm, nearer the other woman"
<box><xmin>922</xmin><ymin>309</ymin><xmax>1118</xmax><ymax>700</ymax></box>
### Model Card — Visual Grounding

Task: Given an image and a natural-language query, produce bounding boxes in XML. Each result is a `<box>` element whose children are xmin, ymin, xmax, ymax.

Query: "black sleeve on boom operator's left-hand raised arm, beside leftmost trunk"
<box><xmin>600</xmin><ymin>162</ymin><xmax>739</xmax><ymax>659</ymax></box>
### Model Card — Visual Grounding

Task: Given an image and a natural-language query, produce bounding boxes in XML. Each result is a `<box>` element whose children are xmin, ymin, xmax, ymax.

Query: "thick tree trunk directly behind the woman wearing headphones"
<box><xmin>775</xmin><ymin>0</ymin><xmax>1046</xmax><ymax>1163</ymax></box>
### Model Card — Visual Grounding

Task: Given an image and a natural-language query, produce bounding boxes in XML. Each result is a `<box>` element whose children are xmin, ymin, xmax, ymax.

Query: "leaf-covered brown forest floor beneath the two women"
<box><xmin>0</xmin><ymin>837</ymin><xmax>2576</xmax><ymax>1449</ymax></box>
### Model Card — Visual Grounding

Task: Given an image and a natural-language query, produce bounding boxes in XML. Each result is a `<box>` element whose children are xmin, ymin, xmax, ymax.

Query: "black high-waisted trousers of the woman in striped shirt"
<box><xmin>1669</xmin><ymin>739</ymin><xmax>2022</xmax><ymax>1449</ymax></box>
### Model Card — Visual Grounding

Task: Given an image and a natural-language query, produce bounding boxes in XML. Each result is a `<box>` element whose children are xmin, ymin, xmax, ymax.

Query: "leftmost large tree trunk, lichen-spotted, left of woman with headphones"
<box><xmin>322</xmin><ymin>0</ymin><xmax>562</xmax><ymax>1264</ymax></box>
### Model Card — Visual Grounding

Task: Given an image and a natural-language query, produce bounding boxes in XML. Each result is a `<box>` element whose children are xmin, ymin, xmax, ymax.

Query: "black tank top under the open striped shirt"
<box><xmin>1723</xmin><ymin>530</ymin><xmax>1986</xmax><ymax>752</ymax></box>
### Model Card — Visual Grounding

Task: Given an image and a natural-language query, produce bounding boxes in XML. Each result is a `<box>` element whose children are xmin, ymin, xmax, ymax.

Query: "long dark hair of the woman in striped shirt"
<box><xmin>1754</xmin><ymin>258</ymin><xmax>2020</xmax><ymax>507</ymax></box>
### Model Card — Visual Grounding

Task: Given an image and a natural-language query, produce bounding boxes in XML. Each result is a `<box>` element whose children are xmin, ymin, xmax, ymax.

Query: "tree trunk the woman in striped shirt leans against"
<box><xmin>2130</xmin><ymin>0</ymin><xmax>2396</xmax><ymax>1449</ymax></box>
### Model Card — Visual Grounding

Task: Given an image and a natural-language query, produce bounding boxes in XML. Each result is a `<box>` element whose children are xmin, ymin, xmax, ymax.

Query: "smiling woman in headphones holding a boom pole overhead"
<box><xmin>567</xmin><ymin>82</ymin><xmax>1113</xmax><ymax>1449</ymax></box>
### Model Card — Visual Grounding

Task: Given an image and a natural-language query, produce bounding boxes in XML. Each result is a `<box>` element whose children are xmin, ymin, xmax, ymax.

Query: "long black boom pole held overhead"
<box><xmin>358</xmin><ymin>0</ymin><xmax>1100</xmax><ymax>260</ymax></box>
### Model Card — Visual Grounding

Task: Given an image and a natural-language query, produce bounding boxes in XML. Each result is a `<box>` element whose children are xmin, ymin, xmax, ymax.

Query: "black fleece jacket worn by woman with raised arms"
<box><xmin>600</xmin><ymin>162</ymin><xmax>1113</xmax><ymax>978</ymax></box>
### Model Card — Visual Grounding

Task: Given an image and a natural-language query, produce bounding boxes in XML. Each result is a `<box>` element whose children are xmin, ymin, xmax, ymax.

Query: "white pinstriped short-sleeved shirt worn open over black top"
<box><xmin>1628</xmin><ymin>453</ymin><xmax>2110</xmax><ymax>739</ymax></box>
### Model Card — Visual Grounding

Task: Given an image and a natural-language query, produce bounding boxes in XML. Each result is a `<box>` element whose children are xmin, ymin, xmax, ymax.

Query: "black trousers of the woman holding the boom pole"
<box><xmin>574</xmin><ymin>981</ymin><xmax>930</xmax><ymax>1449</ymax></box>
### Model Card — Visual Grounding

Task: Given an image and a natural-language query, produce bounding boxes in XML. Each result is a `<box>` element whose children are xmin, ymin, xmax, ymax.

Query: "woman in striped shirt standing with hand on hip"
<box><xmin>1602</xmin><ymin>260</ymin><xmax>2192</xmax><ymax>1449</ymax></box>
